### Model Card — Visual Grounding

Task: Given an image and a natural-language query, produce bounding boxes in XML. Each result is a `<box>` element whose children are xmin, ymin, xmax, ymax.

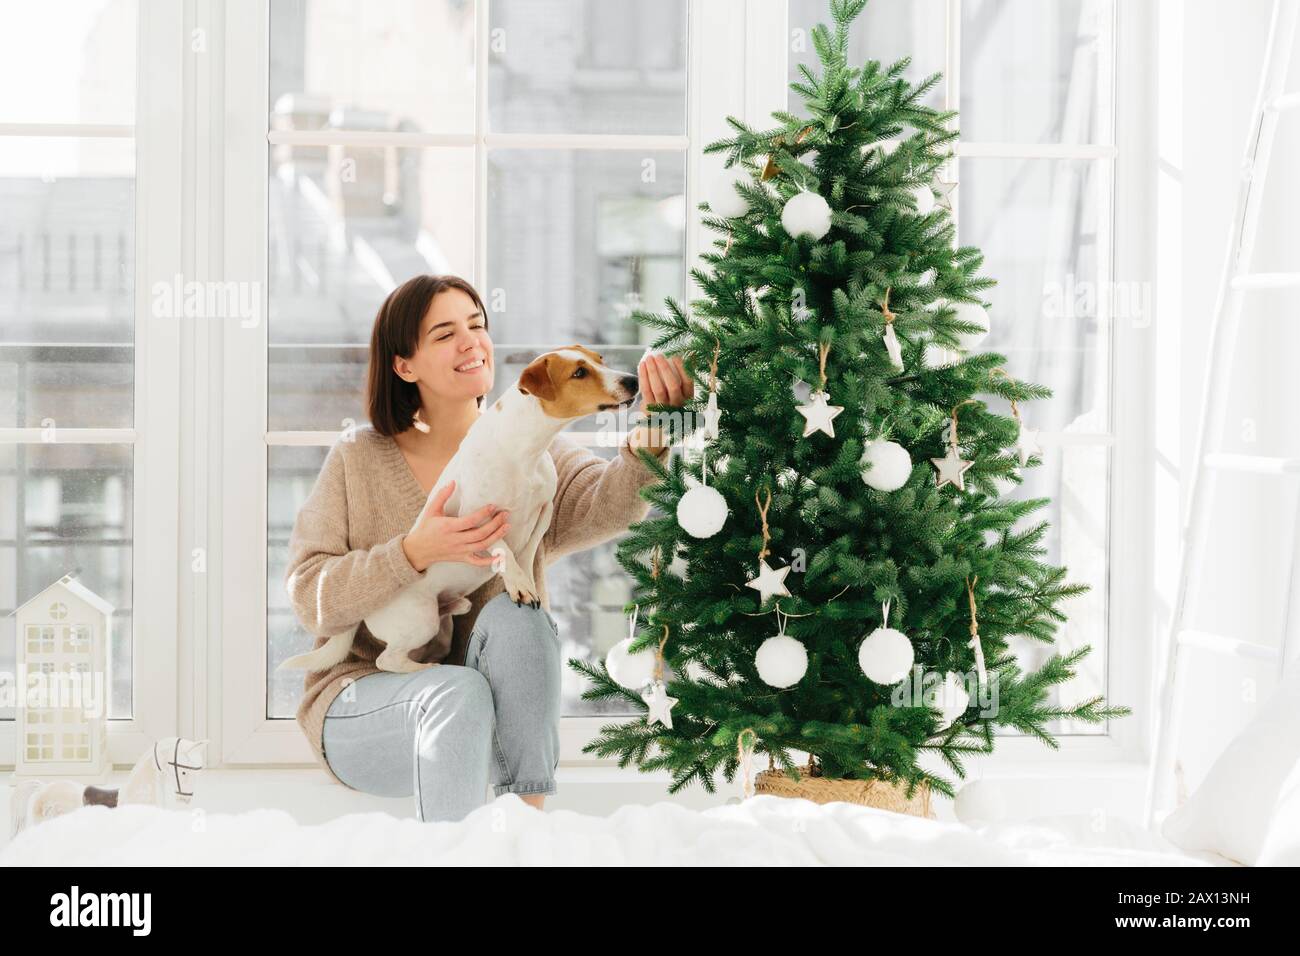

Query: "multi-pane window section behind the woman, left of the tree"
<box><xmin>267</xmin><ymin>0</ymin><xmax>688</xmax><ymax>718</ymax></box>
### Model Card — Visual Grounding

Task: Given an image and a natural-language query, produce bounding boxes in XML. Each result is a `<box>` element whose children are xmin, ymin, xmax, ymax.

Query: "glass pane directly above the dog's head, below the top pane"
<box><xmin>481</xmin><ymin>150</ymin><xmax>685</xmax><ymax>345</ymax></box>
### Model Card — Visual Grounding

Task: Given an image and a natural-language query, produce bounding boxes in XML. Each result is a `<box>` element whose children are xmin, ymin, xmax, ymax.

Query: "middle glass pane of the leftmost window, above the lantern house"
<box><xmin>0</xmin><ymin>137</ymin><xmax>135</xmax><ymax>428</ymax></box>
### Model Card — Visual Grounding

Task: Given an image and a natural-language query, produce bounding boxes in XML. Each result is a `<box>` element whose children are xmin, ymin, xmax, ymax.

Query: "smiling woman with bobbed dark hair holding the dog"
<box><xmin>285</xmin><ymin>276</ymin><xmax>694</xmax><ymax>821</ymax></box>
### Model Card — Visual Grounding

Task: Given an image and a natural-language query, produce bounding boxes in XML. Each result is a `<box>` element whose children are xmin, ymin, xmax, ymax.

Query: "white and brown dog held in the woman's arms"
<box><xmin>277</xmin><ymin>345</ymin><xmax>638</xmax><ymax>672</ymax></box>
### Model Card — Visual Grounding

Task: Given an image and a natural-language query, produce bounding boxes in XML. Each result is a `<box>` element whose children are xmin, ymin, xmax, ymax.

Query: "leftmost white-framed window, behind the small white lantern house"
<box><xmin>0</xmin><ymin>0</ymin><xmax>182</xmax><ymax>763</ymax></box>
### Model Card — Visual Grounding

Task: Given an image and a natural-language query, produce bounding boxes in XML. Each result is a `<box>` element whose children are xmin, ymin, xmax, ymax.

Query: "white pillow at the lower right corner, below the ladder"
<box><xmin>1161</xmin><ymin>667</ymin><xmax>1300</xmax><ymax>866</ymax></box>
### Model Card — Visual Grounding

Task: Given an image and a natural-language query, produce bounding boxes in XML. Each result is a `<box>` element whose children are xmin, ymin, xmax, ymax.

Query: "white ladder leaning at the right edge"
<box><xmin>1143</xmin><ymin>0</ymin><xmax>1300</xmax><ymax>829</ymax></box>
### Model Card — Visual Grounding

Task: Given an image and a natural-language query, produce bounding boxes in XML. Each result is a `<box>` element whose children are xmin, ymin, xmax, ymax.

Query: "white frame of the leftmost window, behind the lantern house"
<box><xmin>0</xmin><ymin>0</ymin><xmax>189</xmax><ymax>766</ymax></box>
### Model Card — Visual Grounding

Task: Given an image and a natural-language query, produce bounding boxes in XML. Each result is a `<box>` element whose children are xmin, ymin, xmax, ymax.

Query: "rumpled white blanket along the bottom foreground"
<box><xmin>0</xmin><ymin>793</ymin><xmax>1226</xmax><ymax>866</ymax></box>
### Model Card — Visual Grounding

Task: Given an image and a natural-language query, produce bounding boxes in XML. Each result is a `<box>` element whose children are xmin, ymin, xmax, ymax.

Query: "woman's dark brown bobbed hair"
<box><xmin>365</xmin><ymin>276</ymin><xmax>488</xmax><ymax>438</ymax></box>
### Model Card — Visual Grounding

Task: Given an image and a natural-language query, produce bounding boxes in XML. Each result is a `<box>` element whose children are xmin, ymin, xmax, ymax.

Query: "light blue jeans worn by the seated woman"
<box><xmin>321</xmin><ymin>593</ymin><xmax>560</xmax><ymax>821</ymax></box>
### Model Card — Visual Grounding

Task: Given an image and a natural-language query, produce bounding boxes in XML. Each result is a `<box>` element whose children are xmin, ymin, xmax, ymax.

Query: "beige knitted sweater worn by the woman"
<box><xmin>285</xmin><ymin>425</ymin><xmax>668</xmax><ymax>783</ymax></box>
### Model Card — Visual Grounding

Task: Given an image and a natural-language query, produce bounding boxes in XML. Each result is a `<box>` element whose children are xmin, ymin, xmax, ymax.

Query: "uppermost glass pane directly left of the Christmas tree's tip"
<box><xmin>488</xmin><ymin>0</ymin><xmax>686</xmax><ymax>135</ymax></box>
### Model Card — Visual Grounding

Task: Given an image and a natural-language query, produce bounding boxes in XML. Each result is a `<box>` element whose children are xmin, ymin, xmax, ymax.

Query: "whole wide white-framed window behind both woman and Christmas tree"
<box><xmin>213</xmin><ymin>0</ymin><xmax>1140</xmax><ymax>762</ymax></box>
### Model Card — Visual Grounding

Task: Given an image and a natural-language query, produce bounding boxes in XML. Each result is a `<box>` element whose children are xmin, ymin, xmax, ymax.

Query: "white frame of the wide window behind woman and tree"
<box><xmin>215</xmin><ymin>0</ymin><xmax>1154</xmax><ymax>766</ymax></box>
